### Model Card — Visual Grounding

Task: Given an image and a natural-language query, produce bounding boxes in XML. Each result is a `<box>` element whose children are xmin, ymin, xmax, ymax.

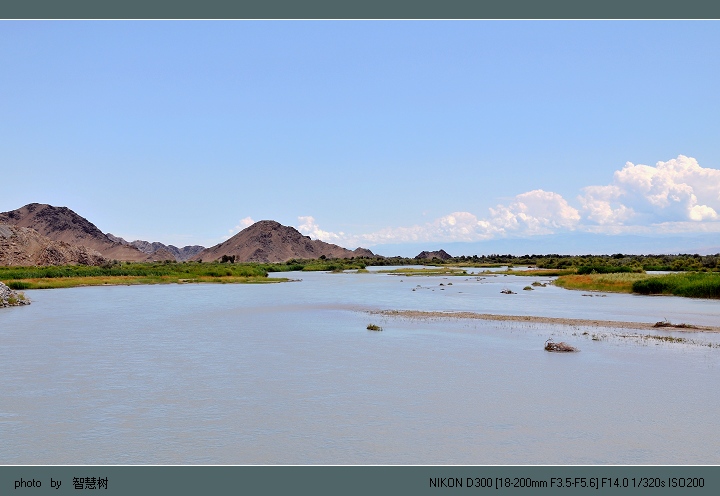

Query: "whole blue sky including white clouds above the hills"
<box><xmin>0</xmin><ymin>21</ymin><xmax>720</xmax><ymax>253</ymax></box>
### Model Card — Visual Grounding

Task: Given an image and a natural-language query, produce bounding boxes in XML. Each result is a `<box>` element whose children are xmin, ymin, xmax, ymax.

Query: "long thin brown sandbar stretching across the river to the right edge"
<box><xmin>369</xmin><ymin>310</ymin><xmax>720</xmax><ymax>332</ymax></box>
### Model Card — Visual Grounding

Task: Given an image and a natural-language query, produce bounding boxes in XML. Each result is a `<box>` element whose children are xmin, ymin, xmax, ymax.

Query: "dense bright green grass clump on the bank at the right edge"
<box><xmin>632</xmin><ymin>272</ymin><xmax>720</xmax><ymax>298</ymax></box>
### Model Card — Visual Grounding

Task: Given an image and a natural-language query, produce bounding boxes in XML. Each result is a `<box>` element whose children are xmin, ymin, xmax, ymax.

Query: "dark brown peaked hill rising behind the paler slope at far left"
<box><xmin>0</xmin><ymin>203</ymin><xmax>148</xmax><ymax>262</ymax></box>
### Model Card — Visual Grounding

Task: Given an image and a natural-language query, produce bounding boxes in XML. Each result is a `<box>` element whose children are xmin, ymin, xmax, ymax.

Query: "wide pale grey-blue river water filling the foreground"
<box><xmin>0</xmin><ymin>273</ymin><xmax>720</xmax><ymax>464</ymax></box>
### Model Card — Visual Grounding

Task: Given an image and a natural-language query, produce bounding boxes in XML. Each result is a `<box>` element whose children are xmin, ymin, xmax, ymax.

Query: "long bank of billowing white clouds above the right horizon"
<box><xmin>298</xmin><ymin>155</ymin><xmax>720</xmax><ymax>246</ymax></box>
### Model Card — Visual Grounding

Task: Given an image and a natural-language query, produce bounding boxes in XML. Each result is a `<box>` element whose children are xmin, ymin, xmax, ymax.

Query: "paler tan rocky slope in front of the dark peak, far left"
<box><xmin>0</xmin><ymin>224</ymin><xmax>107</xmax><ymax>266</ymax></box>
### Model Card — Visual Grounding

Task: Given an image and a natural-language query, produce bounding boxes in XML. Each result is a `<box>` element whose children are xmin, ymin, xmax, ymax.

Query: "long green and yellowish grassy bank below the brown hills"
<box><xmin>0</xmin><ymin>263</ymin><xmax>287</xmax><ymax>289</ymax></box>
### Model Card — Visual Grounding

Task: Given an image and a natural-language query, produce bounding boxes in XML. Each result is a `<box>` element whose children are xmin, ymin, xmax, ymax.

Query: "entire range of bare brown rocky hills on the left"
<box><xmin>0</xmin><ymin>203</ymin><xmax>373</xmax><ymax>265</ymax></box>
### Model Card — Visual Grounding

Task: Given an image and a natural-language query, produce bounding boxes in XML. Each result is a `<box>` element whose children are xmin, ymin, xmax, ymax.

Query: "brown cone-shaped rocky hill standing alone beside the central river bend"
<box><xmin>192</xmin><ymin>220</ymin><xmax>373</xmax><ymax>263</ymax></box>
